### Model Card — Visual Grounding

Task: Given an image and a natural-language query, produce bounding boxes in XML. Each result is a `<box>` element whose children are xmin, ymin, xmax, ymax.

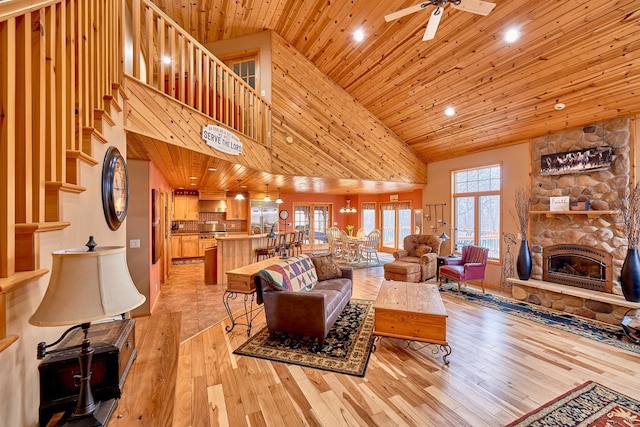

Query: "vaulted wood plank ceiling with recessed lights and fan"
<box><xmin>134</xmin><ymin>0</ymin><xmax>640</xmax><ymax>194</ymax></box>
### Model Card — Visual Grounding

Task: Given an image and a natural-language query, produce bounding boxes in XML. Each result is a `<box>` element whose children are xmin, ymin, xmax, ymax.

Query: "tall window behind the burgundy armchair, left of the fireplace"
<box><xmin>452</xmin><ymin>165</ymin><xmax>502</xmax><ymax>259</ymax></box>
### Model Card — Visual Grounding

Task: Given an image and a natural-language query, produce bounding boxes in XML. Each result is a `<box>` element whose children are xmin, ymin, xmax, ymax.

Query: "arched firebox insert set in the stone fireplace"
<box><xmin>542</xmin><ymin>244</ymin><xmax>613</xmax><ymax>293</ymax></box>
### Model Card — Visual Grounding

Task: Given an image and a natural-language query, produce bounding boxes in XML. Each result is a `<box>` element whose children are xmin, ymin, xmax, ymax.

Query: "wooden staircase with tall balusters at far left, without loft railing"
<box><xmin>0</xmin><ymin>0</ymin><xmax>125</xmax><ymax>351</ymax></box>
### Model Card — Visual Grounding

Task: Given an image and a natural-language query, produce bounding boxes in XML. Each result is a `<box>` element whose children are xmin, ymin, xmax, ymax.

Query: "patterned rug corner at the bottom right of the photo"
<box><xmin>507</xmin><ymin>381</ymin><xmax>640</xmax><ymax>427</ymax></box>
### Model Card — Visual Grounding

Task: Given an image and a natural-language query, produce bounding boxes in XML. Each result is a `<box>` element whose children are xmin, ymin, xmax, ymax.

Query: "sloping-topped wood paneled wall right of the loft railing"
<box><xmin>271</xmin><ymin>33</ymin><xmax>427</xmax><ymax>183</ymax></box>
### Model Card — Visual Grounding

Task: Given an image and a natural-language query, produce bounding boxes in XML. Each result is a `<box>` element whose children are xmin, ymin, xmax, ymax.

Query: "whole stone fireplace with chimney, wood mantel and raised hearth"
<box><xmin>510</xmin><ymin>118</ymin><xmax>637</xmax><ymax>324</ymax></box>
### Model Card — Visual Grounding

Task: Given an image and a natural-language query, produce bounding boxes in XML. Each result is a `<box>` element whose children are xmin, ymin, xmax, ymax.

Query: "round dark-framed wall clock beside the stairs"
<box><xmin>102</xmin><ymin>147</ymin><xmax>129</xmax><ymax>230</ymax></box>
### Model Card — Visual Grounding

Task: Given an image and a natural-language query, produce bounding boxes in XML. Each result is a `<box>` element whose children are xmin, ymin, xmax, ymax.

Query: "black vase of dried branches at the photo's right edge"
<box><xmin>620</xmin><ymin>183</ymin><xmax>640</xmax><ymax>302</ymax></box>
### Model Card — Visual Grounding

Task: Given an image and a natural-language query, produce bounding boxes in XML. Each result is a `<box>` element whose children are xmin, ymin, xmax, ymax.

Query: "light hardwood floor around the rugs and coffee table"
<box><xmin>128</xmin><ymin>260</ymin><xmax>640</xmax><ymax>426</ymax></box>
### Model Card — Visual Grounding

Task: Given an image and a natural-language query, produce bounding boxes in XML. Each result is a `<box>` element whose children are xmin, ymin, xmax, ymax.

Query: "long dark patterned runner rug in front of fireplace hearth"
<box><xmin>440</xmin><ymin>283</ymin><xmax>640</xmax><ymax>354</ymax></box>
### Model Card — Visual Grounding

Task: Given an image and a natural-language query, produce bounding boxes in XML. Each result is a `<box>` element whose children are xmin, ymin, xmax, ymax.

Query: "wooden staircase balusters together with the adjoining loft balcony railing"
<box><xmin>0</xmin><ymin>0</ymin><xmax>271</xmax><ymax>351</ymax></box>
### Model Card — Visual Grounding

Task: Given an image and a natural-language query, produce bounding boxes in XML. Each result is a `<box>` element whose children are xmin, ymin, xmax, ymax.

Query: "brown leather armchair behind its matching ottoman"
<box><xmin>393</xmin><ymin>234</ymin><xmax>442</xmax><ymax>282</ymax></box>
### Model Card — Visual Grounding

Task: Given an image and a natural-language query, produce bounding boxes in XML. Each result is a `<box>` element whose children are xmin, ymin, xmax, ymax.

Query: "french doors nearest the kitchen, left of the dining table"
<box><xmin>293</xmin><ymin>203</ymin><xmax>331</xmax><ymax>250</ymax></box>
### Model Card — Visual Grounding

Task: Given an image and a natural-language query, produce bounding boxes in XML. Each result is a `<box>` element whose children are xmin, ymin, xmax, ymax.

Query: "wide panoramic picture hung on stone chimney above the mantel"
<box><xmin>540</xmin><ymin>145</ymin><xmax>613</xmax><ymax>175</ymax></box>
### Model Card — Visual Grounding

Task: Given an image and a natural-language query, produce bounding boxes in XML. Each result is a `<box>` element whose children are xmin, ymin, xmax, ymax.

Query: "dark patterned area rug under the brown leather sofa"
<box><xmin>233</xmin><ymin>299</ymin><xmax>373</xmax><ymax>377</ymax></box>
